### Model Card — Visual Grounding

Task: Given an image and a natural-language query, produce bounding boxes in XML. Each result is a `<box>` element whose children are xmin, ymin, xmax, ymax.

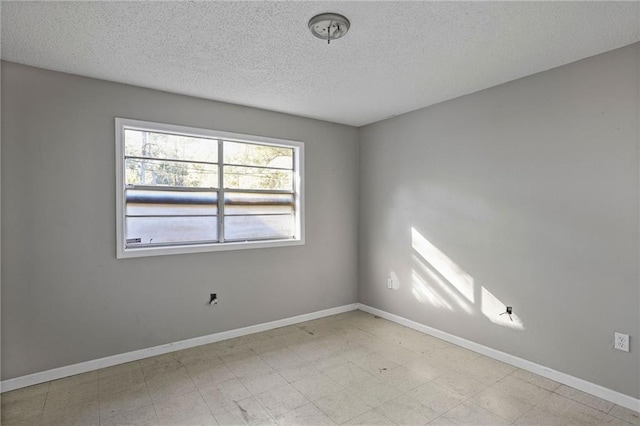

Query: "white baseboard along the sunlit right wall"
<box><xmin>358</xmin><ymin>303</ymin><xmax>640</xmax><ymax>411</ymax></box>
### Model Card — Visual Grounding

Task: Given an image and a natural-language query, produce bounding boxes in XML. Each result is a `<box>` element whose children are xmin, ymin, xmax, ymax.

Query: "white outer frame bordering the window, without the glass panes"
<box><xmin>115</xmin><ymin>118</ymin><xmax>305</xmax><ymax>259</ymax></box>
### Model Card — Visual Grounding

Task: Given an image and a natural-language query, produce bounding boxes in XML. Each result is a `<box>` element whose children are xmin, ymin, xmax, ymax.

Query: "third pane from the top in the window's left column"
<box><xmin>126</xmin><ymin>189</ymin><xmax>218</xmax><ymax>216</ymax></box>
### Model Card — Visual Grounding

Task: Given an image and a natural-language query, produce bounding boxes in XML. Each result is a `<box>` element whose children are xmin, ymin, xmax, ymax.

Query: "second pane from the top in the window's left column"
<box><xmin>125</xmin><ymin>158</ymin><xmax>218</xmax><ymax>188</ymax></box>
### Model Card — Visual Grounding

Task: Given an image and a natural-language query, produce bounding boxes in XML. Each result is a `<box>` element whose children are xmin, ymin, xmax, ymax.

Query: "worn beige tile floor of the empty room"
<box><xmin>1</xmin><ymin>311</ymin><xmax>640</xmax><ymax>426</ymax></box>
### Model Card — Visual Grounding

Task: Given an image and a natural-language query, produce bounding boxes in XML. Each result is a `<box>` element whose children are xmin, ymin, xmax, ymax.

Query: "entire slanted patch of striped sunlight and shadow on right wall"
<box><xmin>411</xmin><ymin>228</ymin><xmax>524</xmax><ymax>330</ymax></box>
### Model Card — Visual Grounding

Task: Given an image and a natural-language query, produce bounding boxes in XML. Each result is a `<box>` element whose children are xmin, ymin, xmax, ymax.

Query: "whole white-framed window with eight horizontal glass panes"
<box><xmin>116</xmin><ymin>118</ymin><xmax>304</xmax><ymax>258</ymax></box>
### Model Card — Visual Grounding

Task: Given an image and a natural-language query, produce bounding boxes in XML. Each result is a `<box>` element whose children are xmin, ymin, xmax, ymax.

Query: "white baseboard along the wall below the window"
<box><xmin>0</xmin><ymin>303</ymin><xmax>358</xmax><ymax>392</ymax></box>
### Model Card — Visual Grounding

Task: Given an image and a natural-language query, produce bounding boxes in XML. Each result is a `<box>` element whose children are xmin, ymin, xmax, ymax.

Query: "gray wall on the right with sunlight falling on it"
<box><xmin>359</xmin><ymin>44</ymin><xmax>640</xmax><ymax>398</ymax></box>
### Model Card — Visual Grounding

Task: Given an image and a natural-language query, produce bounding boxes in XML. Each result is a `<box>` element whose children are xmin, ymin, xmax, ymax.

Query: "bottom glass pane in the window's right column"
<box><xmin>224</xmin><ymin>215</ymin><xmax>294</xmax><ymax>240</ymax></box>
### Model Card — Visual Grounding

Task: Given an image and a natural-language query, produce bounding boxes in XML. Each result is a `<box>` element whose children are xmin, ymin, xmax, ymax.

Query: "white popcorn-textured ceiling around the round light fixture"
<box><xmin>1</xmin><ymin>1</ymin><xmax>640</xmax><ymax>126</ymax></box>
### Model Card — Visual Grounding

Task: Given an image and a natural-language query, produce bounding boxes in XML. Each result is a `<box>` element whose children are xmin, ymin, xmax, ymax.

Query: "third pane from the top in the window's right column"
<box><xmin>224</xmin><ymin>192</ymin><xmax>293</xmax><ymax>215</ymax></box>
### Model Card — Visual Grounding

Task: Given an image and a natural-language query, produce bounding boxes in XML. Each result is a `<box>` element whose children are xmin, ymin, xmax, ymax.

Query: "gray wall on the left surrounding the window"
<box><xmin>1</xmin><ymin>62</ymin><xmax>358</xmax><ymax>379</ymax></box>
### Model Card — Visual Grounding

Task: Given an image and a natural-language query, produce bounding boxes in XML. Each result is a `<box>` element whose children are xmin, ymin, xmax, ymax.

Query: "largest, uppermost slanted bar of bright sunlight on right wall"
<box><xmin>411</xmin><ymin>228</ymin><xmax>474</xmax><ymax>303</ymax></box>
